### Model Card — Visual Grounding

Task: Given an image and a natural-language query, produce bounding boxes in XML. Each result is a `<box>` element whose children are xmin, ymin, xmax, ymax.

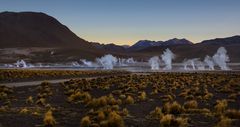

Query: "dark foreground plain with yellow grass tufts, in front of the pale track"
<box><xmin>0</xmin><ymin>72</ymin><xmax>240</xmax><ymax>127</ymax></box>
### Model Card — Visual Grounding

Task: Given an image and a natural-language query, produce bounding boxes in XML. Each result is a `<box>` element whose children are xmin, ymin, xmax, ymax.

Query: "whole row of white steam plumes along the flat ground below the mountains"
<box><xmin>0</xmin><ymin>47</ymin><xmax>230</xmax><ymax>70</ymax></box>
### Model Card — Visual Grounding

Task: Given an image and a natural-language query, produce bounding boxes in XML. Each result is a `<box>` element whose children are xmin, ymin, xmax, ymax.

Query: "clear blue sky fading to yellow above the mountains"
<box><xmin>0</xmin><ymin>0</ymin><xmax>240</xmax><ymax>45</ymax></box>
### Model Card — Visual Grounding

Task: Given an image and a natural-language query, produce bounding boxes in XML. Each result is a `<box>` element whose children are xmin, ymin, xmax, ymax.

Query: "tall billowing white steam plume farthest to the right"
<box><xmin>213</xmin><ymin>47</ymin><xmax>230</xmax><ymax>70</ymax></box>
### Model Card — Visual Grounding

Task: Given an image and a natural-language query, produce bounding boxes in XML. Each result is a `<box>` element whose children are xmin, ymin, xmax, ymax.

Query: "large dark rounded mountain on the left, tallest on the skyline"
<box><xmin>0</xmin><ymin>12</ymin><xmax>91</xmax><ymax>48</ymax></box>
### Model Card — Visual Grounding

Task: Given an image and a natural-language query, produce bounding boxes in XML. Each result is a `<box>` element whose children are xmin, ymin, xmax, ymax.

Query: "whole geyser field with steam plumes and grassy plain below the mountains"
<box><xmin>0</xmin><ymin>47</ymin><xmax>240</xmax><ymax>127</ymax></box>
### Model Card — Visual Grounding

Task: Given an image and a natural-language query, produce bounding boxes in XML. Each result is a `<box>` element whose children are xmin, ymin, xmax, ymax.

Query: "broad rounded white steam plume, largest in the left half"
<box><xmin>96</xmin><ymin>54</ymin><xmax>118</xmax><ymax>69</ymax></box>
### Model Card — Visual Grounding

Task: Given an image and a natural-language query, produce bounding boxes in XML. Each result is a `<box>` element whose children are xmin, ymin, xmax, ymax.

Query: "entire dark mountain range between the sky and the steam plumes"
<box><xmin>0</xmin><ymin>12</ymin><xmax>240</xmax><ymax>63</ymax></box>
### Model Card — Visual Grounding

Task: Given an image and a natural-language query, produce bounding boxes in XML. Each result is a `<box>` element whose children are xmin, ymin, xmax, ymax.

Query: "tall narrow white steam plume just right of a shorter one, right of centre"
<box><xmin>161</xmin><ymin>48</ymin><xmax>175</xmax><ymax>70</ymax></box>
